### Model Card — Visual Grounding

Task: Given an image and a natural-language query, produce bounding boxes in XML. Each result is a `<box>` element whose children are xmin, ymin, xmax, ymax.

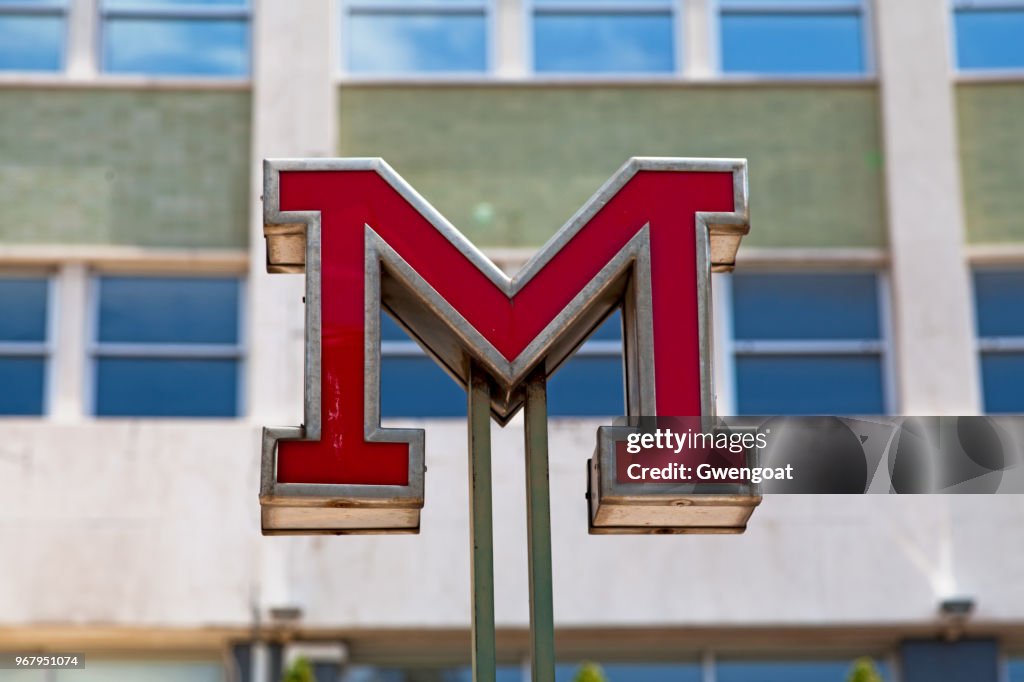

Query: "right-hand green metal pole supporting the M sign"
<box><xmin>525</xmin><ymin>371</ymin><xmax>555</xmax><ymax>682</ymax></box>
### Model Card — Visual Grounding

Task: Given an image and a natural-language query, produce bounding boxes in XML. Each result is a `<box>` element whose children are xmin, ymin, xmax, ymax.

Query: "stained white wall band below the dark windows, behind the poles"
<box><xmin>0</xmin><ymin>421</ymin><xmax>1024</xmax><ymax>628</ymax></box>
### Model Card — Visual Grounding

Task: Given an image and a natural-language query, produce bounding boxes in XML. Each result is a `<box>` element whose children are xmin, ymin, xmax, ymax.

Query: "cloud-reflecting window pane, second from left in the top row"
<box><xmin>103</xmin><ymin>18</ymin><xmax>249</xmax><ymax>76</ymax></box>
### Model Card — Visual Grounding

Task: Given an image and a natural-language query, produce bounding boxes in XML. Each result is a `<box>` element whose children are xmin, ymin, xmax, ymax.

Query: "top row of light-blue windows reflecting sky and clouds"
<box><xmin>0</xmin><ymin>0</ymin><xmax>1024</xmax><ymax>77</ymax></box>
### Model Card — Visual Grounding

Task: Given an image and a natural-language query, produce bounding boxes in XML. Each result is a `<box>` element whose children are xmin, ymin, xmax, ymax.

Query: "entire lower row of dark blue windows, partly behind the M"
<box><xmin>0</xmin><ymin>270</ymin><xmax>1024</xmax><ymax>418</ymax></box>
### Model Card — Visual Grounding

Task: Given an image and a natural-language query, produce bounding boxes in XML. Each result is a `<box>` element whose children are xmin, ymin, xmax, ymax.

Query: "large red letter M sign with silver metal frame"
<box><xmin>260</xmin><ymin>158</ymin><xmax>750</xmax><ymax>534</ymax></box>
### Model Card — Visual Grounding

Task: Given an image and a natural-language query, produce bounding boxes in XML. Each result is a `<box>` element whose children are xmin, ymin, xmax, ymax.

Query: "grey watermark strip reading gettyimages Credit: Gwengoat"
<box><xmin>610</xmin><ymin>416</ymin><xmax>1024</xmax><ymax>494</ymax></box>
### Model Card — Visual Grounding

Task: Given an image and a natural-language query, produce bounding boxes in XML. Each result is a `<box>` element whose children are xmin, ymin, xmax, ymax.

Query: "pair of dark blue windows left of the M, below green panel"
<box><xmin>0</xmin><ymin>276</ymin><xmax>243</xmax><ymax>417</ymax></box>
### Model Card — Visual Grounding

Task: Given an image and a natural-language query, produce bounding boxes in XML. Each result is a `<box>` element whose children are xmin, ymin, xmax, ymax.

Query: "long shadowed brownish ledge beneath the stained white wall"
<box><xmin>0</xmin><ymin>622</ymin><xmax>1024</xmax><ymax>665</ymax></box>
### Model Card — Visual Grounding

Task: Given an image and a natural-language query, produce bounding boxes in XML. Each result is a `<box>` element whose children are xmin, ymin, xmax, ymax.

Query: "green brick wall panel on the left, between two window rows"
<box><xmin>0</xmin><ymin>89</ymin><xmax>251</xmax><ymax>248</ymax></box>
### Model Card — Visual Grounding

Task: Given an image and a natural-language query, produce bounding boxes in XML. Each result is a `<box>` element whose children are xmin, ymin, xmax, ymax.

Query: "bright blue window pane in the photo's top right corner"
<box><xmin>955</xmin><ymin>9</ymin><xmax>1024</xmax><ymax>69</ymax></box>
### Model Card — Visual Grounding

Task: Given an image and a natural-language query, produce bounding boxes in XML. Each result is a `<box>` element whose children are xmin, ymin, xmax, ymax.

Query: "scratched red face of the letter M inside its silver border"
<box><xmin>278</xmin><ymin>171</ymin><xmax>733</xmax><ymax>485</ymax></box>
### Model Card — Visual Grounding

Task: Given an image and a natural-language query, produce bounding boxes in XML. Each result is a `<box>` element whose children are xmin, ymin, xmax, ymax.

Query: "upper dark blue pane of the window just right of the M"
<box><xmin>732</xmin><ymin>272</ymin><xmax>880</xmax><ymax>340</ymax></box>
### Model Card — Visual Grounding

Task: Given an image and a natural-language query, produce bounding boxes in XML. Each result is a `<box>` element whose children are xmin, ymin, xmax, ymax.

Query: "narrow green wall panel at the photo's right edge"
<box><xmin>956</xmin><ymin>83</ymin><xmax>1024</xmax><ymax>243</ymax></box>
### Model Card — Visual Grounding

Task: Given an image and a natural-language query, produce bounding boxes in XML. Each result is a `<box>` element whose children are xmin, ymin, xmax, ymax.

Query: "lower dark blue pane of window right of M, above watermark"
<box><xmin>736</xmin><ymin>355</ymin><xmax>885</xmax><ymax>415</ymax></box>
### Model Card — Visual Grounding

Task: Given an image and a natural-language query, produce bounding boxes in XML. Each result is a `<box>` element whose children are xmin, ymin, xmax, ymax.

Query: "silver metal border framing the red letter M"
<box><xmin>260</xmin><ymin>158</ymin><xmax>750</xmax><ymax>518</ymax></box>
